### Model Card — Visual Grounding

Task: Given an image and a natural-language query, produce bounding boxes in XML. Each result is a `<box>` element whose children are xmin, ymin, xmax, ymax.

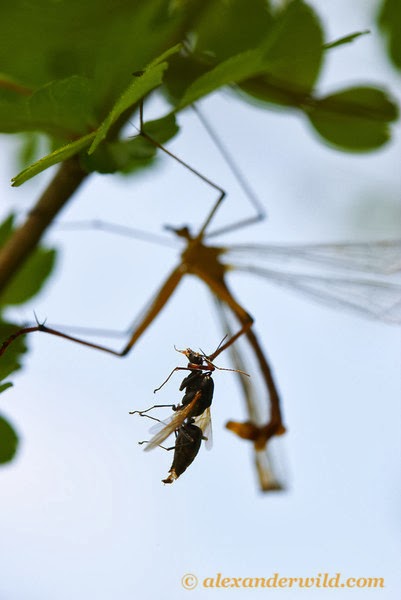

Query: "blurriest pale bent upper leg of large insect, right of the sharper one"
<box><xmin>192</xmin><ymin>104</ymin><xmax>266</xmax><ymax>237</ymax></box>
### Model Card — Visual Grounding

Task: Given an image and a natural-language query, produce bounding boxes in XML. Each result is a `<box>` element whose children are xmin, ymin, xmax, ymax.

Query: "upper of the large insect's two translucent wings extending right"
<box><xmin>226</xmin><ymin>239</ymin><xmax>401</xmax><ymax>275</ymax></box>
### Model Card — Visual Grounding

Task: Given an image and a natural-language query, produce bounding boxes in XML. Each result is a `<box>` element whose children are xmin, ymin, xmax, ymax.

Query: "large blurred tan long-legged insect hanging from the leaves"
<box><xmin>0</xmin><ymin>101</ymin><xmax>401</xmax><ymax>490</ymax></box>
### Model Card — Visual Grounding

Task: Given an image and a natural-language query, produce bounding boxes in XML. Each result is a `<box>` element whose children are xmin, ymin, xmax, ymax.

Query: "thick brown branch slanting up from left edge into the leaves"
<box><xmin>0</xmin><ymin>156</ymin><xmax>87</xmax><ymax>291</ymax></box>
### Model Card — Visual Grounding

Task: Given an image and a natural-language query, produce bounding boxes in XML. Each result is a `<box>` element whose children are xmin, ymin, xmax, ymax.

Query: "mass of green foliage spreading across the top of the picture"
<box><xmin>0</xmin><ymin>0</ymin><xmax>397</xmax><ymax>185</ymax></box>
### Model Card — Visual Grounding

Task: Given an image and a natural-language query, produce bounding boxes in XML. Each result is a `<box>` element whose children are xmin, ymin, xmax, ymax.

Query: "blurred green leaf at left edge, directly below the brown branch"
<box><xmin>0</xmin><ymin>217</ymin><xmax>56</xmax><ymax>306</ymax></box>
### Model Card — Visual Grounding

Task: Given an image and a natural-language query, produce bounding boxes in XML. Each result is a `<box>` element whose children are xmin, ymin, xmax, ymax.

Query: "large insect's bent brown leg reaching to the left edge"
<box><xmin>0</xmin><ymin>266</ymin><xmax>183</xmax><ymax>357</ymax></box>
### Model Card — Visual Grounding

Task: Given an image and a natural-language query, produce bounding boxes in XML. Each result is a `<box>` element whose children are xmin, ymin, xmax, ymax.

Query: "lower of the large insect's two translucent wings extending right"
<box><xmin>228</xmin><ymin>265</ymin><xmax>401</xmax><ymax>323</ymax></box>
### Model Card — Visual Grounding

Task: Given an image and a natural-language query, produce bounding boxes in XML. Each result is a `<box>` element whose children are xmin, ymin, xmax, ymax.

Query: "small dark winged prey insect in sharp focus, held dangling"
<box><xmin>130</xmin><ymin>325</ymin><xmax>250</xmax><ymax>483</ymax></box>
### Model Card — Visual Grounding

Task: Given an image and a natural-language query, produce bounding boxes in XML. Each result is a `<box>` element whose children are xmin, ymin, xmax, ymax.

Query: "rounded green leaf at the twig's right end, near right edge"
<box><xmin>306</xmin><ymin>87</ymin><xmax>398</xmax><ymax>152</ymax></box>
